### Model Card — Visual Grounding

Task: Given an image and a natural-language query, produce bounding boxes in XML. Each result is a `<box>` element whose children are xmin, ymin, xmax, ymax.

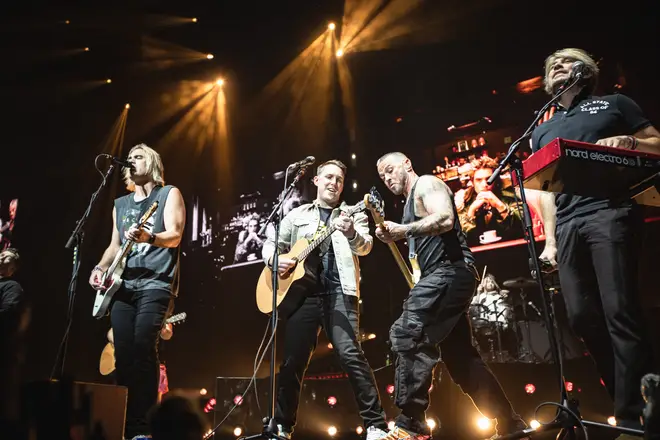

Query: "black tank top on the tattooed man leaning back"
<box><xmin>402</xmin><ymin>176</ymin><xmax>474</xmax><ymax>275</ymax></box>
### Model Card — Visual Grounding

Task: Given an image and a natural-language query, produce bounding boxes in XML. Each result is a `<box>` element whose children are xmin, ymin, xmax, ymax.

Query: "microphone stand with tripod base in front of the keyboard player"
<box><xmin>488</xmin><ymin>77</ymin><xmax>644</xmax><ymax>440</ymax></box>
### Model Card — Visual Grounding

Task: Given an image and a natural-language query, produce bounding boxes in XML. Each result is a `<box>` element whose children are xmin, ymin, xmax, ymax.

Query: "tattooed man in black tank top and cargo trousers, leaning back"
<box><xmin>376</xmin><ymin>152</ymin><xmax>526</xmax><ymax>439</ymax></box>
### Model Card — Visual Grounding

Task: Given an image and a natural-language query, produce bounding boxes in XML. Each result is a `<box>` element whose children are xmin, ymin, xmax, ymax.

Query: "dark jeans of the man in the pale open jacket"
<box><xmin>275</xmin><ymin>294</ymin><xmax>387</xmax><ymax>432</ymax></box>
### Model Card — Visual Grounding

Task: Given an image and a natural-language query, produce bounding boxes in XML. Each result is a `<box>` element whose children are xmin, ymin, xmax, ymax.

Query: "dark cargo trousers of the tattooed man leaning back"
<box><xmin>390</xmin><ymin>263</ymin><xmax>520</xmax><ymax>433</ymax></box>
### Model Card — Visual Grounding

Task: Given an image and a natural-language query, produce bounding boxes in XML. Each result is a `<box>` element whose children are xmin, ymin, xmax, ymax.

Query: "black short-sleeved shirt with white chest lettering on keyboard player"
<box><xmin>532</xmin><ymin>95</ymin><xmax>651</xmax><ymax>225</ymax></box>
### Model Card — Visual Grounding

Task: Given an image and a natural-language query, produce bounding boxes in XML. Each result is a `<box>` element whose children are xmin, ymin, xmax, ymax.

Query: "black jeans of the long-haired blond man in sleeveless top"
<box><xmin>110</xmin><ymin>288</ymin><xmax>172</xmax><ymax>438</ymax></box>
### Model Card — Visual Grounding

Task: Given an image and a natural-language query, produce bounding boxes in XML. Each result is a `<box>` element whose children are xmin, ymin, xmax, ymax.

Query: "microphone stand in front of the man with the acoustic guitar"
<box><xmin>243</xmin><ymin>163</ymin><xmax>311</xmax><ymax>440</ymax></box>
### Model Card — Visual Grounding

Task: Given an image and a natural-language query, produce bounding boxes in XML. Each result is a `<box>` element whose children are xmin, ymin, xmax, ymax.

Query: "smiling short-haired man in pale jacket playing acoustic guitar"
<box><xmin>262</xmin><ymin>160</ymin><xmax>387</xmax><ymax>440</ymax></box>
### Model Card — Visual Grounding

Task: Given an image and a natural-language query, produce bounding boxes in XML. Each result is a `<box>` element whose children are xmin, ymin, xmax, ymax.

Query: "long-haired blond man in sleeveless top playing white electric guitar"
<box><xmin>89</xmin><ymin>144</ymin><xmax>186</xmax><ymax>439</ymax></box>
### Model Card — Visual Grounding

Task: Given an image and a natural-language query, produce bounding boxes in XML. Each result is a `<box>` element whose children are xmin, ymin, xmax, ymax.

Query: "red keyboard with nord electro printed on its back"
<box><xmin>523</xmin><ymin>138</ymin><xmax>660</xmax><ymax>206</ymax></box>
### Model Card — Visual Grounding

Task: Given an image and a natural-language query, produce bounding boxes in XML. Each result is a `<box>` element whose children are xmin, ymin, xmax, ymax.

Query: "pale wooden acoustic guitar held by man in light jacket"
<box><xmin>256</xmin><ymin>200</ymin><xmax>365</xmax><ymax>317</ymax></box>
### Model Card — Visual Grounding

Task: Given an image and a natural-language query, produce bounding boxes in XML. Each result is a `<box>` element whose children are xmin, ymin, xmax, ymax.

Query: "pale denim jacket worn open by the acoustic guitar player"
<box><xmin>262</xmin><ymin>200</ymin><xmax>373</xmax><ymax>296</ymax></box>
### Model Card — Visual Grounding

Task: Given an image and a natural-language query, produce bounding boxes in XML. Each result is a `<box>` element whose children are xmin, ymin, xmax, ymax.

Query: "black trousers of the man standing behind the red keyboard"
<box><xmin>557</xmin><ymin>208</ymin><xmax>653</xmax><ymax>429</ymax></box>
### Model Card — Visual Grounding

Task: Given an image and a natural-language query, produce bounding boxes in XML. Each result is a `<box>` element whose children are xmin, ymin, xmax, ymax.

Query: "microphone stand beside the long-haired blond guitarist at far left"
<box><xmin>50</xmin><ymin>160</ymin><xmax>115</xmax><ymax>380</ymax></box>
